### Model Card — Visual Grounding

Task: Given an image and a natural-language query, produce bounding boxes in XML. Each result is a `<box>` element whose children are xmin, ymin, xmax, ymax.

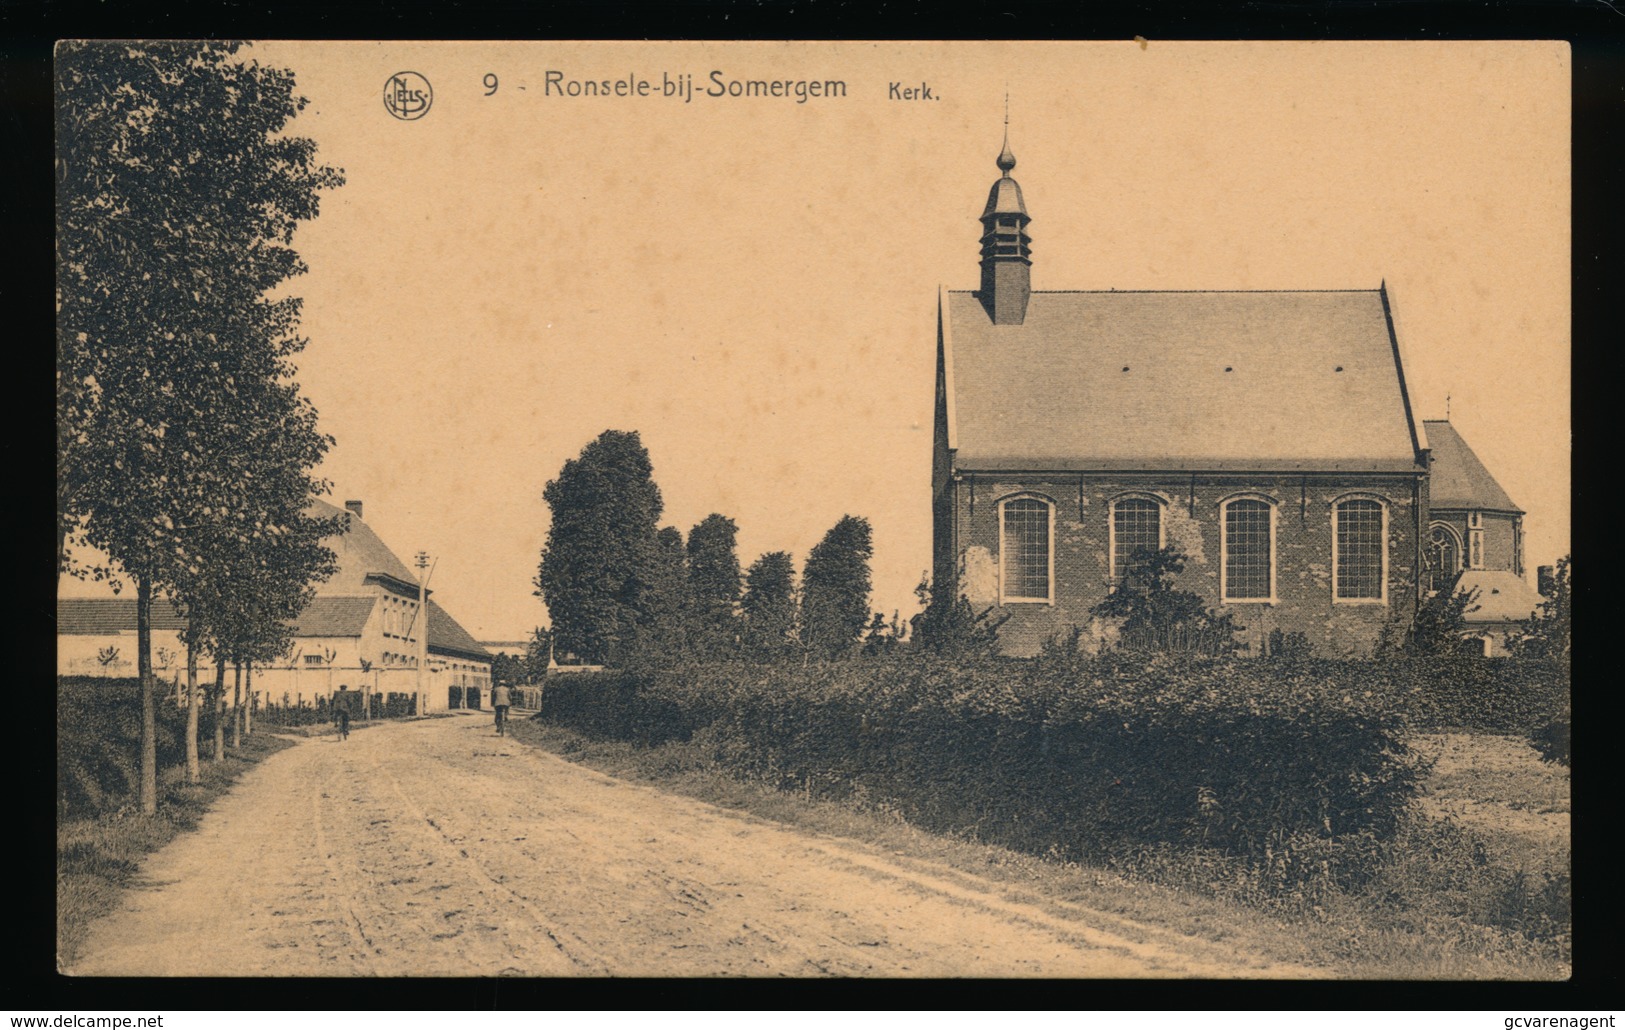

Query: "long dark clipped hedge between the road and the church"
<box><xmin>541</xmin><ymin>653</ymin><xmax>1449</xmax><ymax>879</ymax></box>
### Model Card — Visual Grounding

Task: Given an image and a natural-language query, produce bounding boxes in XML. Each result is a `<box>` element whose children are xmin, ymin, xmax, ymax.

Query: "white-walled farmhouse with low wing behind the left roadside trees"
<box><xmin>57</xmin><ymin>500</ymin><xmax>491</xmax><ymax>712</ymax></box>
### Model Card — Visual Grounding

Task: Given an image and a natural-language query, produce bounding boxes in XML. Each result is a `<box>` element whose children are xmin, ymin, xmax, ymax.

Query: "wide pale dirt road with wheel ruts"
<box><xmin>68</xmin><ymin>715</ymin><xmax>1307</xmax><ymax>976</ymax></box>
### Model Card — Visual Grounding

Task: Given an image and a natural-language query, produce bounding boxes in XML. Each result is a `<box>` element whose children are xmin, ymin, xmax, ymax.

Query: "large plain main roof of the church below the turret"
<box><xmin>941</xmin><ymin>289</ymin><xmax>1417</xmax><ymax>471</ymax></box>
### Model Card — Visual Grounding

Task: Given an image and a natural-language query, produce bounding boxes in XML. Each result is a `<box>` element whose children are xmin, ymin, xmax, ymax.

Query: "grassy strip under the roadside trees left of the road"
<box><xmin>57</xmin><ymin>731</ymin><xmax>293</xmax><ymax>970</ymax></box>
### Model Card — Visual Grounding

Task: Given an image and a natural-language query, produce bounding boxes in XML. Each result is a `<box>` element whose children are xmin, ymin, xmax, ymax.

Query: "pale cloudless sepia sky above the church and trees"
<box><xmin>57</xmin><ymin>41</ymin><xmax>1570</xmax><ymax>640</ymax></box>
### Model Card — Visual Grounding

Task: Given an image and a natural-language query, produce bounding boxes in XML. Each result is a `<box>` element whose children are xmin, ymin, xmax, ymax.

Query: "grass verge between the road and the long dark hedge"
<box><xmin>514</xmin><ymin>708</ymin><xmax>1570</xmax><ymax>980</ymax></box>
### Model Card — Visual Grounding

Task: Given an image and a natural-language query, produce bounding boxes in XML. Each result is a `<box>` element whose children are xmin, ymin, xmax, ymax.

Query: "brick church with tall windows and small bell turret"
<box><xmin>931</xmin><ymin>141</ymin><xmax>1539</xmax><ymax>655</ymax></box>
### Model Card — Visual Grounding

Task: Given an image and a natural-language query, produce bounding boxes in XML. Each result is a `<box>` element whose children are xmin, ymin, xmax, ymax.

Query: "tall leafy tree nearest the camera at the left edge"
<box><xmin>57</xmin><ymin>42</ymin><xmax>343</xmax><ymax>812</ymax></box>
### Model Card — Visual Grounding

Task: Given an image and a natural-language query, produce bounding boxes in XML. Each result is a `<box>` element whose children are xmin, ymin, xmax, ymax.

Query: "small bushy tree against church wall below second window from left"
<box><xmin>1090</xmin><ymin>546</ymin><xmax>1246</xmax><ymax>656</ymax></box>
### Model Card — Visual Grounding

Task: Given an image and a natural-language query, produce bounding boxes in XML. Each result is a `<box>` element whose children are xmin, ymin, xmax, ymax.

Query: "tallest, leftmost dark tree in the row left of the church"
<box><xmin>535</xmin><ymin>429</ymin><xmax>670</xmax><ymax>664</ymax></box>
